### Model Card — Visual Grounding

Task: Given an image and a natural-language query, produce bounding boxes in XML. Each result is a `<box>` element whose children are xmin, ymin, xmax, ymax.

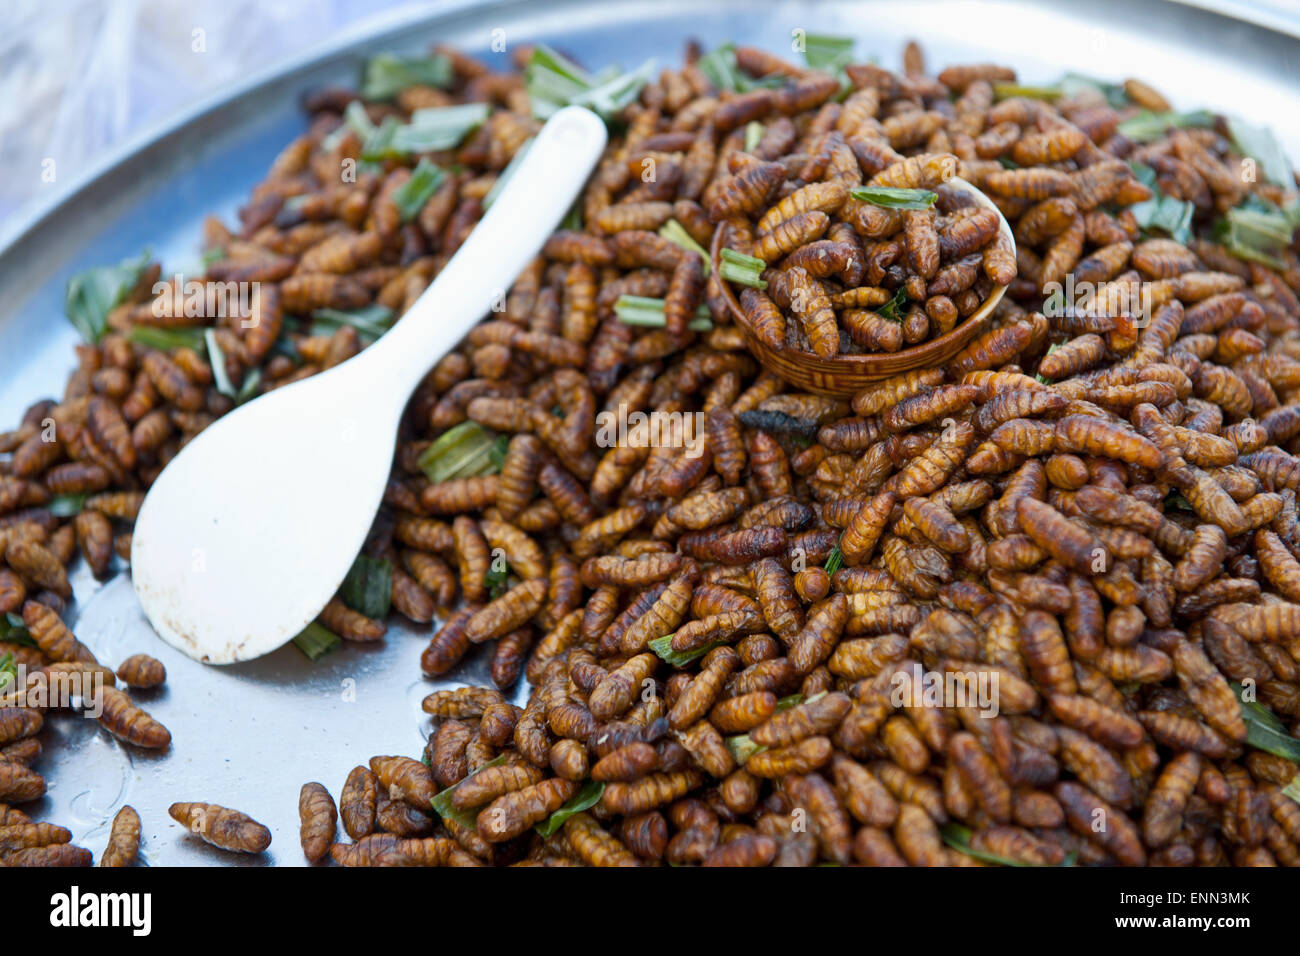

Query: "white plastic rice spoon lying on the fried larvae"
<box><xmin>131</xmin><ymin>107</ymin><xmax>606</xmax><ymax>663</ymax></box>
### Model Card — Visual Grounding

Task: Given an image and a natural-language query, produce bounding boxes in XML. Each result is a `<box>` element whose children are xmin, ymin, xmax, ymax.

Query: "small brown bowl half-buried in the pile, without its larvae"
<box><xmin>709</xmin><ymin>177</ymin><xmax>1015</xmax><ymax>397</ymax></box>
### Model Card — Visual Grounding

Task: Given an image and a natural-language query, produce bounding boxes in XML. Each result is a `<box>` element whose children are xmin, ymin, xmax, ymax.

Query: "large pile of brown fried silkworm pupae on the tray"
<box><xmin>0</xmin><ymin>39</ymin><xmax>1300</xmax><ymax>866</ymax></box>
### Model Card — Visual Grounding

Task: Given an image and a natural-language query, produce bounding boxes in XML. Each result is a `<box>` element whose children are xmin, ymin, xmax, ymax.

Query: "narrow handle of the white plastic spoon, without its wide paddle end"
<box><xmin>356</xmin><ymin>107</ymin><xmax>606</xmax><ymax>403</ymax></box>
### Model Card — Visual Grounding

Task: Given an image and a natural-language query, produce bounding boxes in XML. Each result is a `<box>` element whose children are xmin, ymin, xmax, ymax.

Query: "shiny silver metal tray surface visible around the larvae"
<box><xmin>0</xmin><ymin>0</ymin><xmax>1300</xmax><ymax>866</ymax></box>
